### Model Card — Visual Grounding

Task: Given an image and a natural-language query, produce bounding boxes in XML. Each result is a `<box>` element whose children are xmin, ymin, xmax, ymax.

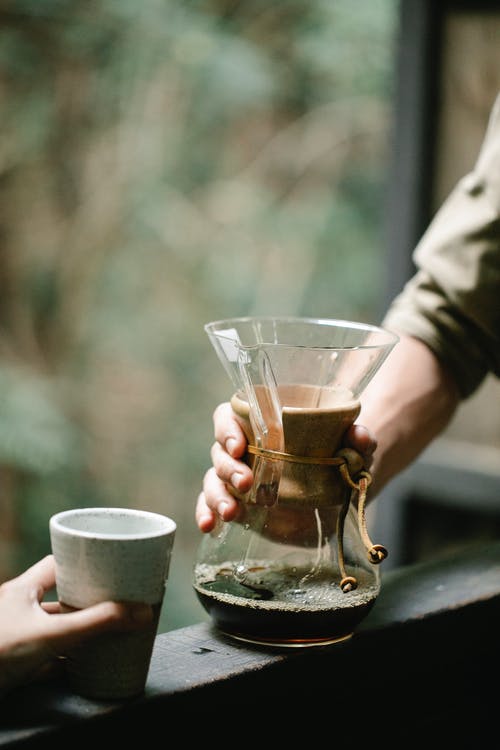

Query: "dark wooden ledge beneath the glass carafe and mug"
<box><xmin>0</xmin><ymin>543</ymin><xmax>500</xmax><ymax>750</ymax></box>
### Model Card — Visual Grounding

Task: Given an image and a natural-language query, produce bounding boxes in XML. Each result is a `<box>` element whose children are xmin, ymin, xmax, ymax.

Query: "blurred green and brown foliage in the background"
<box><xmin>0</xmin><ymin>0</ymin><xmax>397</xmax><ymax>629</ymax></box>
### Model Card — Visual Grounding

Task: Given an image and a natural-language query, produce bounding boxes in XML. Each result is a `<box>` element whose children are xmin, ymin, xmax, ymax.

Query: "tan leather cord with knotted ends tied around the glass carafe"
<box><xmin>247</xmin><ymin>445</ymin><xmax>387</xmax><ymax>593</ymax></box>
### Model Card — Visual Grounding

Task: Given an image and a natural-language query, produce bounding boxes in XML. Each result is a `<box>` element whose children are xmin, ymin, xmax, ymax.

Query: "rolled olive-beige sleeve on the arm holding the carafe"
<box><xmin>383</xmin><ymin>95</ymin><xmax>500</xmax><ymax>398</ymax></box>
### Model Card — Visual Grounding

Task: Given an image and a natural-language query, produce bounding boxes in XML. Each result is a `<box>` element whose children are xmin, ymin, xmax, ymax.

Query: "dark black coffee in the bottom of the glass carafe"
<box><xmin>194</xmin><ymin>562</ymin><xmax>379</xmax><ymax>646</ymax></box>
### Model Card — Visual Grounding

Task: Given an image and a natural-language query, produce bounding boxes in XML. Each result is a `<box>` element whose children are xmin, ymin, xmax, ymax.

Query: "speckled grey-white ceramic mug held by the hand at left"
<box><xmin>49</xmin><ymin>508</ymin><xmax>176</xmax><ymax>700</ymax></box>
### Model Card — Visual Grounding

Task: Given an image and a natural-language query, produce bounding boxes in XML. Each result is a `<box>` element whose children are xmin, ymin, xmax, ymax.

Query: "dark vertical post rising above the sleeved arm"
<box><xmin>383</xmin><ymin>0</ymin><xmax>442</xmax><ymax>306</ymax></box>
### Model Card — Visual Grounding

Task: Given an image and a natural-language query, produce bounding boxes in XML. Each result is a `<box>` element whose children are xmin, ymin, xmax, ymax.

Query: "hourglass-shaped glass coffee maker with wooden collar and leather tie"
<box><xmin>193</xmin><ymin>317</ymin><xmax>398</xmax><ymax>647</ymax></box>
